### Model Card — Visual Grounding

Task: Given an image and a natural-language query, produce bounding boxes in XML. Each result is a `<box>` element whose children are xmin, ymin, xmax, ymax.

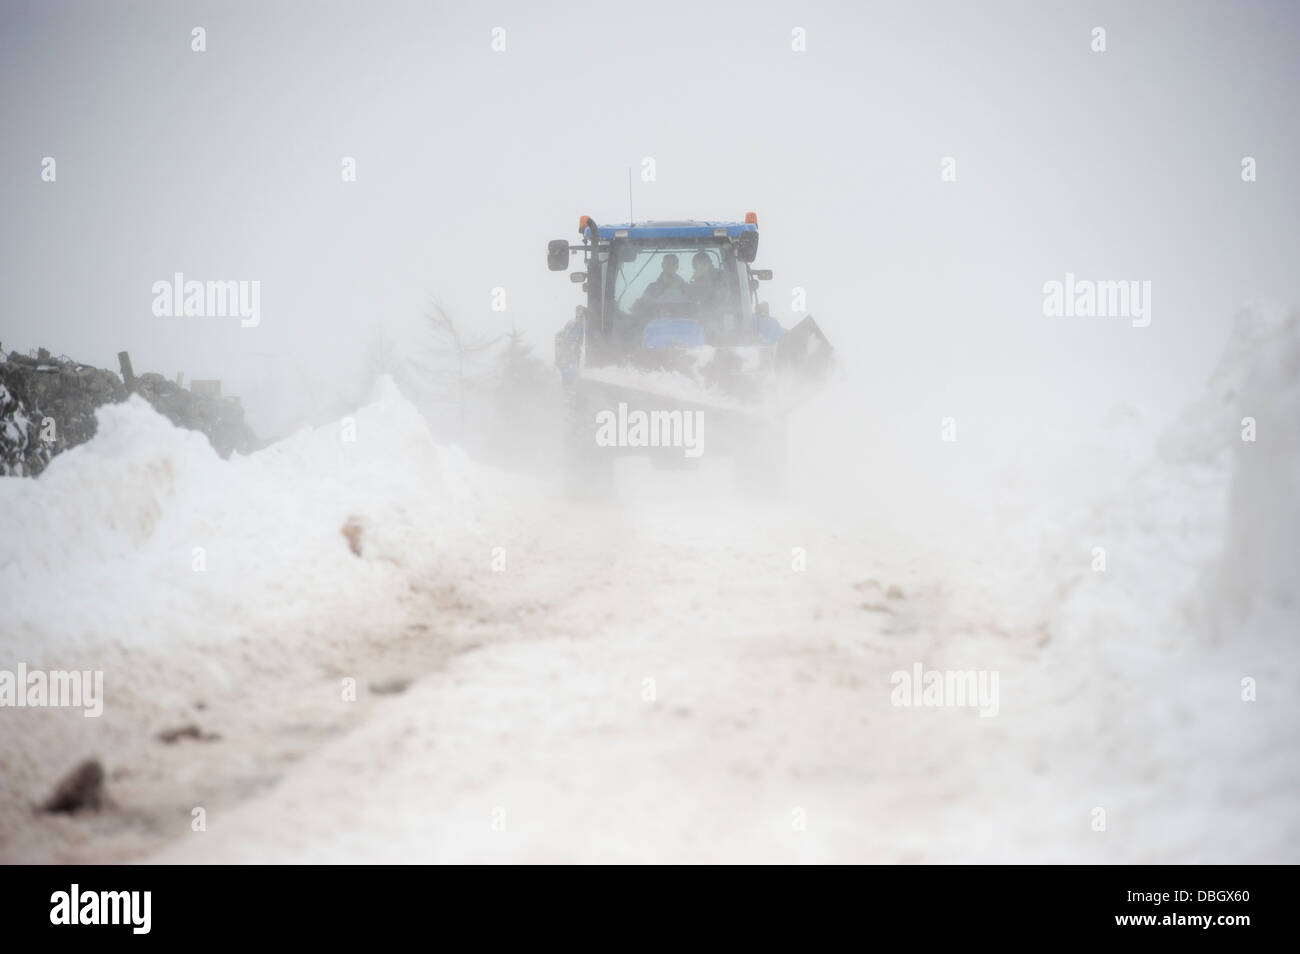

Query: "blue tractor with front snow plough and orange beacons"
<box><xmin>546</xmin><ymin>212</ymin><xmax>833</xmax><ymax>498</ymax></box>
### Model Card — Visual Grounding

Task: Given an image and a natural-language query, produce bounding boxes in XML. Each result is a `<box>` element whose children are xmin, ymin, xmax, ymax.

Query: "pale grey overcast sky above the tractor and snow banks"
<box><xmin>0</xmin><ymin>0</ymin><xmax>1300</xmax><ymax>436</ymax></box>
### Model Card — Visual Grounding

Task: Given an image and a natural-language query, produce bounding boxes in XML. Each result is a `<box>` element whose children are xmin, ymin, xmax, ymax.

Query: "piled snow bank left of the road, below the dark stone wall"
<box><xmin>0</xmin><ymin>378</ymin><xmax>502</xmax><ymax>662</ymax></box>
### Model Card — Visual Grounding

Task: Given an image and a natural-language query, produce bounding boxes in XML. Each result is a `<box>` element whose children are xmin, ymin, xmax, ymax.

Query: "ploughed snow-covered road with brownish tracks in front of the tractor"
<box><xmin>3</xmin><ymin>465</ymin><xmax>1294</xmax><ymax>862</ymax></box>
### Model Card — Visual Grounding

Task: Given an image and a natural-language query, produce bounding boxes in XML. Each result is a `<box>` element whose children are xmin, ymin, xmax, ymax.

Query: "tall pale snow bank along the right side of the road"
<box><xmin>1003</xmin><ymin>308</ymin><xmax>1300</xmax><ymax>863</ymax></box>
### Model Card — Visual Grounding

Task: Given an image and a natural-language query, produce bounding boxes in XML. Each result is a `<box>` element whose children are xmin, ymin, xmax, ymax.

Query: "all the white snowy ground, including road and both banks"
<box><xmin>0</xmin><ymin>313</ymin><xmax>1300</xmax><ymax>863</ymax></box>
